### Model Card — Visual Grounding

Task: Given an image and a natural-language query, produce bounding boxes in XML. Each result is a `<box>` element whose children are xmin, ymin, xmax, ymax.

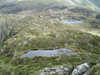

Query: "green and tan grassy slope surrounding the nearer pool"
<box><xmin>0</xmin><ymin>12</ymin><xmax>100</xmax><ymax>75</ymax></box>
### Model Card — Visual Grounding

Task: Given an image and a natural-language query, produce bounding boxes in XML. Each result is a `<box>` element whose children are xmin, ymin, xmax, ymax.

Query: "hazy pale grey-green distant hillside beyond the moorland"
<box><xmin>0</xmin><ymin>0</ymin><xmax>98</xmax><ymax>13</ymax></box>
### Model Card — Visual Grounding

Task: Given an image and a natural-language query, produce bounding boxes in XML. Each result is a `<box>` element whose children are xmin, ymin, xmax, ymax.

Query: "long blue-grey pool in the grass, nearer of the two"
<box><xmin>20</xmin><ymin>48</ymin><xmax>77</xmax><ymax>58</ymax></box>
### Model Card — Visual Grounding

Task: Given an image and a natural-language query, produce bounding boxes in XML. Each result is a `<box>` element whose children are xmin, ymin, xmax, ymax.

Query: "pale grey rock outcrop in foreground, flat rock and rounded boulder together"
<box><xmin>40</xmin><ymin>62</ymin><xmax>96</xmax><ymax>75</ymax></box>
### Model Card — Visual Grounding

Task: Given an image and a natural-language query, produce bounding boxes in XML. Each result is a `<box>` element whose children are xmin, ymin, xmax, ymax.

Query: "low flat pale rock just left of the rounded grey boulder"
<box><xmin>40</xmin><ymin>66</ymin><xmax>71</xmax><ymax>75</ymax></box>
